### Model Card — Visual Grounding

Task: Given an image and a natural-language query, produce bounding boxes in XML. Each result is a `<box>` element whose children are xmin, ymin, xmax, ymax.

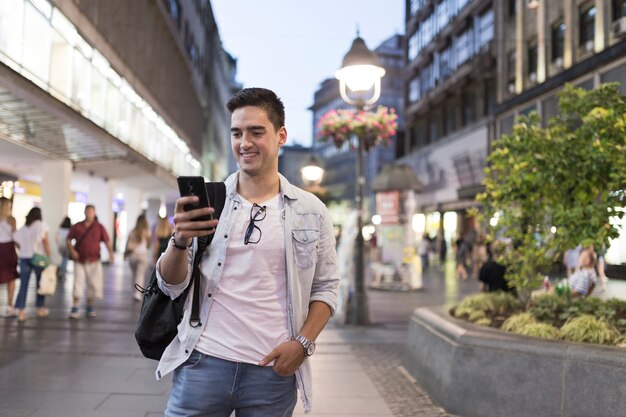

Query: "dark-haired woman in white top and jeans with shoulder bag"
<box><xmin>13</xmin><ymin>207</ymin><xmax>50</xmax><ymax>322</ymax></box>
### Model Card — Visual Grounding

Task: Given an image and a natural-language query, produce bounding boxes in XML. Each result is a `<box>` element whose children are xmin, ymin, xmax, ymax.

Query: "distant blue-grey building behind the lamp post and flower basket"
<box><xmin>310</xmin><ymin>35</ymin><xmax>404</xmax><ymax>223</ymax></box>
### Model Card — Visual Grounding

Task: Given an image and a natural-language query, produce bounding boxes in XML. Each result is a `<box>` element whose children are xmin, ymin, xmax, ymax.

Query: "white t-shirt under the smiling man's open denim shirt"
<box><xmin>196</xmin><ymin>195</ymin><xmax>289</xmax><ymax>365</ymax></box>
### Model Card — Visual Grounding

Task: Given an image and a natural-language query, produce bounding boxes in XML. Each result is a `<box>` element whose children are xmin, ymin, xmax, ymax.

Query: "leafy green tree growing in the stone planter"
<box><xmin>478</xmin><ymin>84</ymin><xmax>626</xmax><ymax>302</ymax></box>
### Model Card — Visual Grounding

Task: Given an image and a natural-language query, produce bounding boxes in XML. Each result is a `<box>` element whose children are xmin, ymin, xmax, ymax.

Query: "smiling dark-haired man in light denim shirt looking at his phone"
<box><xmin>156</xmin><ymin>88</ymin><xmax>339</xmax><ymax>417</ymax></box>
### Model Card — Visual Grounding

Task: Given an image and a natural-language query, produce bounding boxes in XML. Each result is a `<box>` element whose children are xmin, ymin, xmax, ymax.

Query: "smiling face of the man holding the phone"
<box><xmin>230</xmin><ymin>106</ymin><xmax>287</xmax><ymax>177</ymax></box>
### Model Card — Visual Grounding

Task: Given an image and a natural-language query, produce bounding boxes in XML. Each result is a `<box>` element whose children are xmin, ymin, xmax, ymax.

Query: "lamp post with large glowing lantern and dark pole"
<box><xmin>335</xmin><ymin>32</ymin><xmax>385</xmax><ymax>325</ymax></box>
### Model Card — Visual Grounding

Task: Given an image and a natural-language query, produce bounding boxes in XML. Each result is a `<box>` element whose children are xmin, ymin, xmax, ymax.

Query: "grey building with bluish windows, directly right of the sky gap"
<box><xmin>401</xmin><ymin>0</ymin><xmax>501</xmax><ymax>246</ymax></box>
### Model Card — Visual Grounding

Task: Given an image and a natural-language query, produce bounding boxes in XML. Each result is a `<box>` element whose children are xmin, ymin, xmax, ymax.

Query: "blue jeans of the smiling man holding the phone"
<box><xmin>165</xmin><ymin>350</ymin><xmax>296</xmax><ymax>417</ymax></box>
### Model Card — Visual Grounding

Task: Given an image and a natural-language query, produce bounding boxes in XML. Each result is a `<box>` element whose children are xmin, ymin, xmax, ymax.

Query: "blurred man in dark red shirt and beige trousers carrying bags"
<box><xmin>66</xmin><ymin>204</ymin><xmax>114</xmax><ymax>319</ymax></box>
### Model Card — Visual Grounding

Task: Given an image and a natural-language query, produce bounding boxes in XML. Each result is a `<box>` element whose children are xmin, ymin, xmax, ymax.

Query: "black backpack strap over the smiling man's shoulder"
<box><xmin>189</xmin><ymin>182</ymin><xmax>226</xmax><ymax>327</ymax></box>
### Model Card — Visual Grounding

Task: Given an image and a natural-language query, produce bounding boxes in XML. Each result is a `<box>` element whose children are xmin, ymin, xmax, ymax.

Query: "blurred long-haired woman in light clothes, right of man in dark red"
<box><xmin>124</xmin><ymin>214</ymin><xmax>150</xmax><ymax>301</ymax></box>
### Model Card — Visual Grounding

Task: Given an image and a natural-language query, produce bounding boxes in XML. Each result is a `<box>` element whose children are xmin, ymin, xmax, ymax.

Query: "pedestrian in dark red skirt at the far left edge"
<box><xmin>0</xmin><ymin>197</ymin><xmax>18</xmax><ymax>317</ymax></box>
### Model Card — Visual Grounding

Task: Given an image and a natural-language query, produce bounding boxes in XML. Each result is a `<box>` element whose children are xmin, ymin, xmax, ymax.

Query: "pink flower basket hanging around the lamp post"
<box><xmin>317</xmin><ymin>106</ymin><xmax>398</xmax><ymax>151</ymax></box>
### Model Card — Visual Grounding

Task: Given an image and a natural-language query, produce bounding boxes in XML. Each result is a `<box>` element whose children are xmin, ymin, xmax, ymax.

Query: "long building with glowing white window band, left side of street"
<box><xmin>0</xmin><ymin>0</ymin><xmax>235</xmax><ymax>255</ymax></box>
